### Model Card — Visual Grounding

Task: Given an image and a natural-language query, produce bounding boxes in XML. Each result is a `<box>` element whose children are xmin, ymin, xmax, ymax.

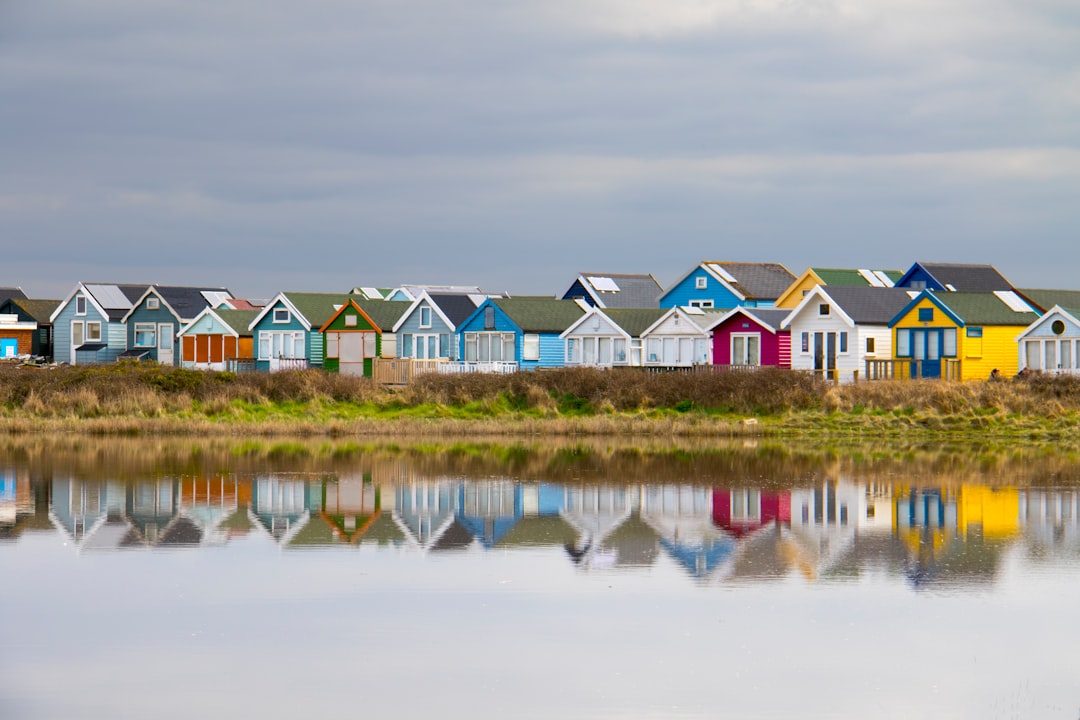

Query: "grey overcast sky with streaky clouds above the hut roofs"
<box><xmin>0</xmin><ymin>0</ymin><xmax>1080</xmax><ymax>297</ymax></box>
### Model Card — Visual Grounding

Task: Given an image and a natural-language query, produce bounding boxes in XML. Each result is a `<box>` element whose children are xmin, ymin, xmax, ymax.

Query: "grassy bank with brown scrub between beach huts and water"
<box><xmin>0</xmin><ymin>364</ymin><xmax>1080</xmax><ymax>439</ymax></box>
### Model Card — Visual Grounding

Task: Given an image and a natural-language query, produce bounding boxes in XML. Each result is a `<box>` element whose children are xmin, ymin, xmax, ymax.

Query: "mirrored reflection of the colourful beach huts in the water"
<box><xmin>6</xmin><ymin>453</ymin><xmax>1080</xmax><ymax>588</ymax></box>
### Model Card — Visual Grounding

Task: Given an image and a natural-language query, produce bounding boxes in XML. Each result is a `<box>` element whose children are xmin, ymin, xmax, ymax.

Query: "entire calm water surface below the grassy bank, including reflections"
<box><xmin>0</xmin><ymin>440</ymin><xmax>1080</xmax><ymax>720</ymax></box>
